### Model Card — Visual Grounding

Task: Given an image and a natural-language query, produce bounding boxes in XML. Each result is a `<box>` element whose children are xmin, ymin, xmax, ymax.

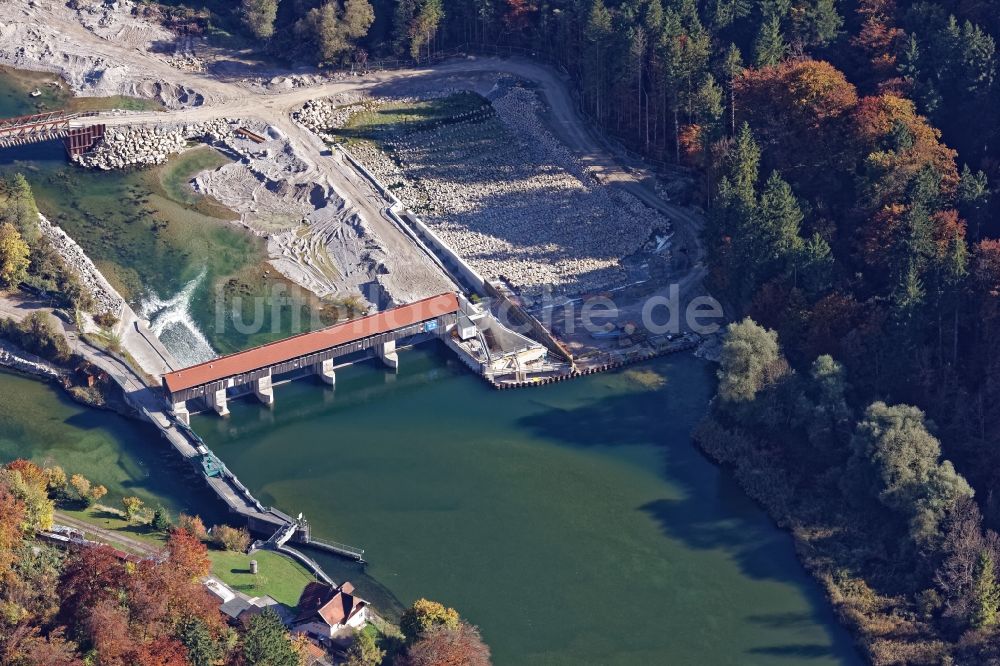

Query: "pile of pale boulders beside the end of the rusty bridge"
<box><xmin>74</xmin><ymin>119</ymin><xmax>235</xmax><ymax>171</ymax></box>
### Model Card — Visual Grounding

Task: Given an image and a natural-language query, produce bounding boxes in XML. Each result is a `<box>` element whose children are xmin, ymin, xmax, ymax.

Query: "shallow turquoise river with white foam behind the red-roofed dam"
<box><xmin>0</xmin><ymin>70</ymin><xmax>329</xmax><ymax>363</ymax></box>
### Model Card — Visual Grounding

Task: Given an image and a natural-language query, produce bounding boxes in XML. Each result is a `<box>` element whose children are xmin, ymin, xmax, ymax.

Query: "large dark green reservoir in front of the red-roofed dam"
<box><xmin>193</xmin><ymin>347</ymin><xmax>854</xmax><ymax>664</ymax></box>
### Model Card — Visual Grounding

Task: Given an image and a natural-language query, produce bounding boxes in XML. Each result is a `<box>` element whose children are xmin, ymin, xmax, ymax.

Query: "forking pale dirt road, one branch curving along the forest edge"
<box><xmin>11</xmin><ymin>0</ymin><xmax>702</xmax><ymax>308</ymax></box>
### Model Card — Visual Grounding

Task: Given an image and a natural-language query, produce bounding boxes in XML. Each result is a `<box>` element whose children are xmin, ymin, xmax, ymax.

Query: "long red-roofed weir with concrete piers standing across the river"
<box><xmin>162</xmin><ymin>293</ymin><xmax>460</xmax><ymax>425</ymax></box>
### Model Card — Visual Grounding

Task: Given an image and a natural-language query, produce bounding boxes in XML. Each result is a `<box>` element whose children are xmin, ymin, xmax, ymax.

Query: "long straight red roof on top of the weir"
<box><xmin>163</xmin><ymin>294</ymin><xmax>458</xmax><ymax>393</ymax></box>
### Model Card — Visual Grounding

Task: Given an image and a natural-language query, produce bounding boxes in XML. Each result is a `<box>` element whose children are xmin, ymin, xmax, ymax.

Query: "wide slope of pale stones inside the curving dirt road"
<box><xmin>344</xmin><ymin>87</ymin><xmax>669</xmax><ymax>295</ymax></box>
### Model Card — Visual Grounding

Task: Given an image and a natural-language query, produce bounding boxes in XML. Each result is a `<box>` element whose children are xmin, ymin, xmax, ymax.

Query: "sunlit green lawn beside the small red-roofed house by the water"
<box><xmin>208</xmin><ymin>550</ymin><xmax>316</xmax><ymax>608</ymax></box>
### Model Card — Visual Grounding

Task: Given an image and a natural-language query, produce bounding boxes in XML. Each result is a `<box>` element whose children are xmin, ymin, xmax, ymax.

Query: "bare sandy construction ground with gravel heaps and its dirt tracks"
<box><xmin>0</xmin><ymin>0</ymin><xmax>701</xmax><ymax>316</ymax></box>
